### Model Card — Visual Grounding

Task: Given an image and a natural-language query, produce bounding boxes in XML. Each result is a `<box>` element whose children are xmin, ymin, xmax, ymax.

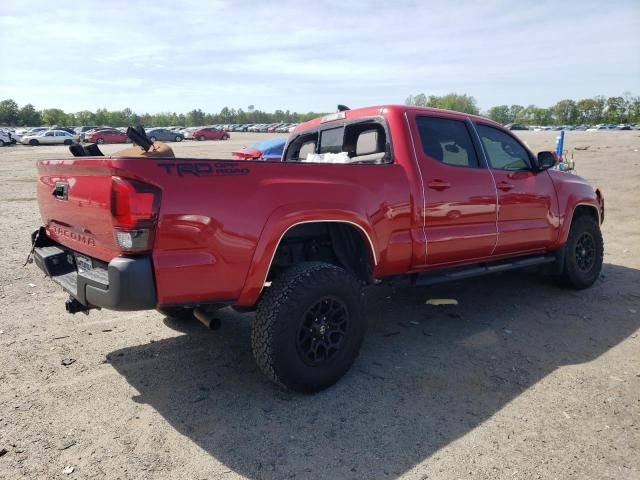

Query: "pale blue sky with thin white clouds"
<box><xmin>0</xmin><ymin>0</ymin><xmax>640</xmax><ymax>113</ymax></box>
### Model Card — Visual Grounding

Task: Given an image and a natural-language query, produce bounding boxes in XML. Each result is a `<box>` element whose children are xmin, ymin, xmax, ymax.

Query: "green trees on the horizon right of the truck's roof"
<box><xmin>405</xmin><ymin>93</ymin><xmax>640</xmax><ymax>125</ymax></box>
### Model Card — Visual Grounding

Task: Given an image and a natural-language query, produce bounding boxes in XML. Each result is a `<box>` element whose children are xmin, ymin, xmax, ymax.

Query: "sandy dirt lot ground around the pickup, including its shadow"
<box><xmin>0</xmin><ymin>131</ymin><xmax>640</xmax><ymax>479</ymax></box>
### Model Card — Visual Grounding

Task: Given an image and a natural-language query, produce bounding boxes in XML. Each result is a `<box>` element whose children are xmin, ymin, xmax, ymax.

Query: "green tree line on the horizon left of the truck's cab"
<box><xmin>0</xmin><ymin>99</ymin><xmax>324</xmax><ymax>127</ymax></box>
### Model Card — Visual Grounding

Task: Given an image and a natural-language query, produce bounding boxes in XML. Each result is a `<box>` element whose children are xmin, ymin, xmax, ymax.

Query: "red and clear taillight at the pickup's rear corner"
<box><xmin>111</xmin><ymin>177</ymin><xmax>160</xmax><ymax>253</ymax></box>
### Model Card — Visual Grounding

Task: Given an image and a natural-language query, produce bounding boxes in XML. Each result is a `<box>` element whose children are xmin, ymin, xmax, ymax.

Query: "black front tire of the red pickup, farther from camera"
<box><xmin>554</xmin><ymin>215</ymin><xmax>604</xmax><ymax>290</ymax></box>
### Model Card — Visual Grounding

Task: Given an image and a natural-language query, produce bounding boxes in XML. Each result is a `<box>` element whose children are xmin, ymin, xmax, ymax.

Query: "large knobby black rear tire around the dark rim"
<box><xmin>251</xmin><ymin>262</ymin><xmax>366</xmax><ymax>393</ymax></box>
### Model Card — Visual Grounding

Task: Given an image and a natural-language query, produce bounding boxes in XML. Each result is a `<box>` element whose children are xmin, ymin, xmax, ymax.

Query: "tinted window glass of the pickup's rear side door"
<box><xmin>416</xmin><ymin>116</ymin><xmax>480</xmax><ymax>168</ymax></box>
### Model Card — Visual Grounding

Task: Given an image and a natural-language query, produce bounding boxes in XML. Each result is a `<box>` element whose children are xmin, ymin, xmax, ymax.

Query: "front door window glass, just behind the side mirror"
<box><xmin>476</xmin><ymin>123</ymin><xmax>530</xmax><ymax>170</ymax></box>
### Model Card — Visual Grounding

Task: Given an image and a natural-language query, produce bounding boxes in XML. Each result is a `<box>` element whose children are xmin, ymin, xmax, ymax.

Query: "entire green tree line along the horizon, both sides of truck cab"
<box><xmin>0</xmin><ymin>93</ymin><xmax>640</xmax><ymax>127</ymax></box>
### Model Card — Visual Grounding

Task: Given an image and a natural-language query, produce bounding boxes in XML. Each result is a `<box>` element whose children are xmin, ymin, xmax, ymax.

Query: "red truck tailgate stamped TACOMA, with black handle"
<box><xmin>37</xmin><ymin>158</ymin><xmax>120</xmax><ymax>262</ymax></box>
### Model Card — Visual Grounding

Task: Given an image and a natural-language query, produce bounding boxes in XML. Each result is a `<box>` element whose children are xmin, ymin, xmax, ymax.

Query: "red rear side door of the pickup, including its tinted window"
<box><xmin>408</xmin><ymin>112</ymin><xmax>497</xmax><ymax>266</ymax></box>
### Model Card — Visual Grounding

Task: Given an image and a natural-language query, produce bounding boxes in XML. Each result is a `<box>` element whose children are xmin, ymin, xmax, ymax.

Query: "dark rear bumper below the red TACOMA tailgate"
<box><xmin>33</xmin><ymin>229</ymin><xmax>157</xmax><ymax>310</ymax></box>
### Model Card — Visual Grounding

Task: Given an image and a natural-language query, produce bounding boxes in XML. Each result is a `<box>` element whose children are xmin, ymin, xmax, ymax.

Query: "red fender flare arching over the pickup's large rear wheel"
<box><xmin>236</xmin><ymin>207</ymin><xmax>380</xmax><ymax>306</ymax></box>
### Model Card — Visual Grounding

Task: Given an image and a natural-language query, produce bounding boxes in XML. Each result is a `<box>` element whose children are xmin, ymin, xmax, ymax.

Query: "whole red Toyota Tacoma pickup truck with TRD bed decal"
<box><xmin>32</xmin><ymin>106</ymin><xmax>604</xmax><ymax>392</ymax></box>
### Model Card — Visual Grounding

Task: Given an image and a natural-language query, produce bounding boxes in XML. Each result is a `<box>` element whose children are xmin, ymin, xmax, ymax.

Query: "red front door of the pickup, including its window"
<box><xmin>475</xmin><ymin>123</ymin><xmax>557</xmax><ymax>255</ymax></box>
